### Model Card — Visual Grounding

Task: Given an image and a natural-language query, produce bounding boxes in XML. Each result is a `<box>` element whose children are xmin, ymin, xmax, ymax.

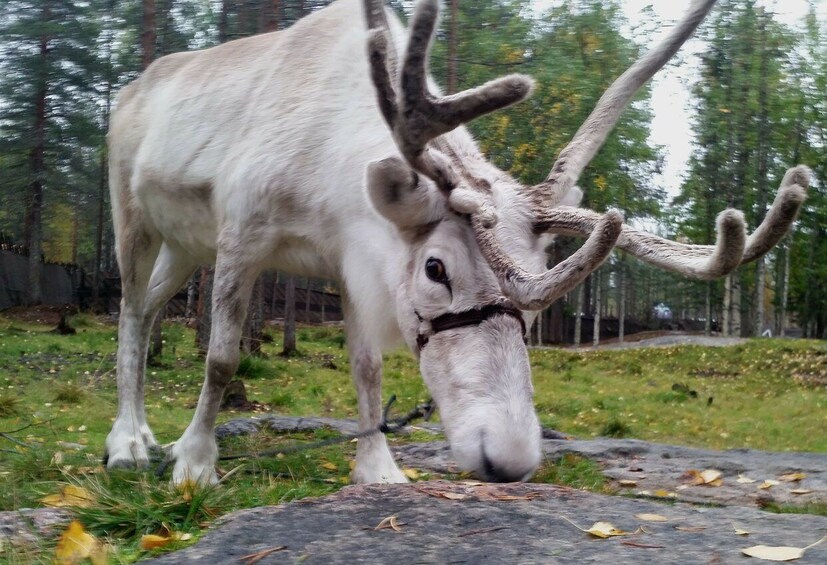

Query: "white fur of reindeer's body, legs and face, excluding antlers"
<box><xmin>107</xmin><ymin>0</ymin><xmax>546</xmax><ymax>483</ymax></box>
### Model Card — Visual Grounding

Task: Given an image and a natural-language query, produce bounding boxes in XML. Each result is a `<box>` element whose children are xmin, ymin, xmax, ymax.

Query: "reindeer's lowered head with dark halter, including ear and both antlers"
<box><xmin>366</xmin><ymin>0</ymin><xmax>808</xmax><ymax>480</ymax></box>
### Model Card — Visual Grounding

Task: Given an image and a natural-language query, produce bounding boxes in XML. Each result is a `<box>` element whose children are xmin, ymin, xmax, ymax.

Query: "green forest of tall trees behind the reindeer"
<box><xmin>0</xmin><ymin>0</ymin><xmax>827</xmax><ymax>341</ymax></box>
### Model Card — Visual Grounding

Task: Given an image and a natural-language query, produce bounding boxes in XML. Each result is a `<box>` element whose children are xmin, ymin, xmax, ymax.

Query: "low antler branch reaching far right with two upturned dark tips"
<box><xmin>535</xmin><ymin>166</ymin><xmax>810</xmax><ymax>279</ymax></box>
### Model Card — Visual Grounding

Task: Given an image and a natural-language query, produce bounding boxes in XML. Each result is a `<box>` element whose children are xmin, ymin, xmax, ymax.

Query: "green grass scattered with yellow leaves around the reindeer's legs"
<box><xmin>0</xmin><ymin>315</ymin><xmax>827</xmax><ymax>563</ymax></box>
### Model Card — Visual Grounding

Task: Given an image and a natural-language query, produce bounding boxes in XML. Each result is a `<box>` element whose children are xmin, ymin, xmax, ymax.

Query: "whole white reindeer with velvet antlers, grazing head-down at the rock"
<box><xmin>106</xmin><ymin>0</ymin><xmax>808</xmax><ymax>483</ymax></box>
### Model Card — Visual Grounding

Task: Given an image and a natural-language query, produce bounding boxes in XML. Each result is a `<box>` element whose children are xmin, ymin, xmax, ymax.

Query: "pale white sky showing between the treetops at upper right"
<box><xmin>535</xmin><ymin>0</ymin><xmax>827</xmax><ymax>197</ymax></box>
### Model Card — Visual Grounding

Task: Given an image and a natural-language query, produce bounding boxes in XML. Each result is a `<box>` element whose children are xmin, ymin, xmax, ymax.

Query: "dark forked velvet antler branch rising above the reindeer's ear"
<box><xmin>369</xmin><ymin>0</ymin><xmax>533</xmax><ymax>186</ymax></box>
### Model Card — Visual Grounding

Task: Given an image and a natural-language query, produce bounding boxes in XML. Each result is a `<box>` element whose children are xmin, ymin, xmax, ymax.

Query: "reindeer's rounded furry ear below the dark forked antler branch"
<box><xmin>367</xmin><ymin>157</ymin><xmax>446</xmax><ymax>230</ymax></box>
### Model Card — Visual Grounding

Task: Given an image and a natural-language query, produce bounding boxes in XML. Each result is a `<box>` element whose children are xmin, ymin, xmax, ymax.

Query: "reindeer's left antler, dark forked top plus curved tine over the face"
<box><xmin>366</xmin><ymin>0</ymin><xmax>622</xmax><ymax>309</ymax></box>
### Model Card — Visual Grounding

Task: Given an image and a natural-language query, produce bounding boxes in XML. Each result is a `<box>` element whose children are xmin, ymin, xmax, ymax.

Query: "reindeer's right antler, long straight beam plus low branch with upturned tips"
<box><xmin>530</xmin><ymin>0</ymin><xmax>810</xmax><ymax>279</ymax></box>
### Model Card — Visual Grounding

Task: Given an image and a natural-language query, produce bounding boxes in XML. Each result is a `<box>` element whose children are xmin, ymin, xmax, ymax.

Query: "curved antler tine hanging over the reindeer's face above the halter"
<box><xmin>471</xmin><ymin>210</ymin><xmax>623</xmax><ymax>310</ymax></box>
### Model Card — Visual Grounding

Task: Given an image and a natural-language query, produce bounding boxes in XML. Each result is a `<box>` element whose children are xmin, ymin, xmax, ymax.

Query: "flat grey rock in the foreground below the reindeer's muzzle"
<box><xmin>149</xmin><ymin>481</ymin><xmax>827</xmax><ymax>565</ymax></box>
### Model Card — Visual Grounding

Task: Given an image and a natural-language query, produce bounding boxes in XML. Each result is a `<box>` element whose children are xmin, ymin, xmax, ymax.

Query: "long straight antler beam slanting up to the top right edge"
<box><xmin>534</xmin><ymin>0</ymin><xmax>715</xmax><ymax>207</ymax></box>
